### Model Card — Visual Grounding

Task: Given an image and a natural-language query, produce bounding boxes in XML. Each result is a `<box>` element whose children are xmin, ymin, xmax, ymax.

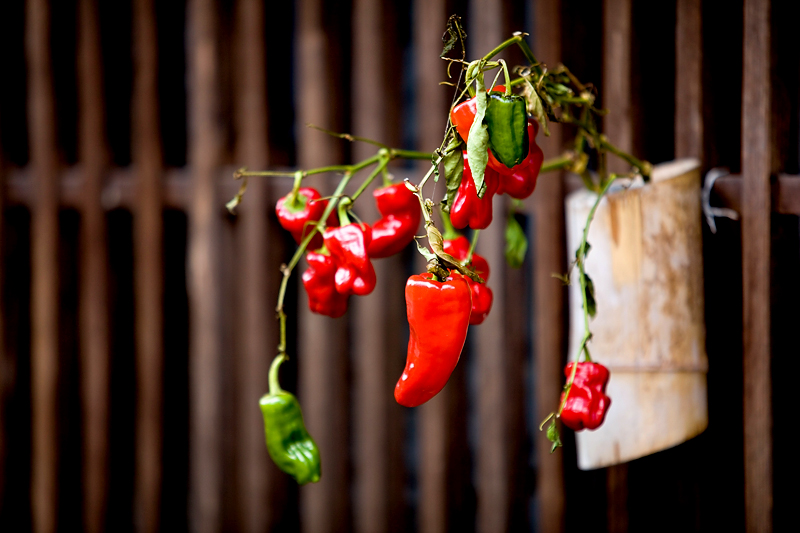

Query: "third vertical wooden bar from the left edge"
<box><xmin>132</xmin><ymin>0</ymin><xmax>164</xmax><ymax>532</ymax></box>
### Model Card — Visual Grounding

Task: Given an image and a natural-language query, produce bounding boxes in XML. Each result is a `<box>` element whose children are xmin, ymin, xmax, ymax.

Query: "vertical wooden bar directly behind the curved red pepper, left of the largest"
<box><xmin>351</xmin><ymin>0</ymin><xmax>405</xmax><ymax>533</ymax></box>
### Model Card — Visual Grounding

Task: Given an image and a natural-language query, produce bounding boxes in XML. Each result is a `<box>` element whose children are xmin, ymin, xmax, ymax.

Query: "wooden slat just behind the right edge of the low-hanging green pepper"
<box><xmin>296</xmin><ymin>0</ymin><xmax>350</xmax><ymax>533</ymax></box>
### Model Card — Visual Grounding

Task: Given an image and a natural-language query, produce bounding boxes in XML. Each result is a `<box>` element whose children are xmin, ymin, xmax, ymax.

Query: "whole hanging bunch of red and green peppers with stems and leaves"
<box><xmin>228</xmin><ymin>16</ymin><xmax>650</xmax><ymax>484</ymax></box>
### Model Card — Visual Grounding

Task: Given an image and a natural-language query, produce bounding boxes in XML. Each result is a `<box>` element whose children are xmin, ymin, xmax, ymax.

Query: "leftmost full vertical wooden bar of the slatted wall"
<box><xmin>25</xmin><ymin>0</ymin><xmax>59</xmax><ymax>533</ymax></box>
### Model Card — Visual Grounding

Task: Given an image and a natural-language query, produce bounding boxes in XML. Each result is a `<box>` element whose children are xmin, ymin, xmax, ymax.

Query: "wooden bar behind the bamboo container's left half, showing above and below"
<box><xmin>601</xmin><ymin>0</ymin><xmax>633</xmax><ymax>533</ymax></box>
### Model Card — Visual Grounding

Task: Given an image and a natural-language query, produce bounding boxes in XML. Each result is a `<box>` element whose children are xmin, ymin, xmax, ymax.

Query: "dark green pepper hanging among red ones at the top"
<box><xmin>484</xmin><ymin>92</ymin><xmax>528</xmax><ymax>168</ymax></box>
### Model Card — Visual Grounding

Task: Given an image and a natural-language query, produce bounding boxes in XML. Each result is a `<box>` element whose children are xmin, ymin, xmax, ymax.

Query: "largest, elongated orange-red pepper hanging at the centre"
<box><xmin>394</xmin><ymin>273</ymin><xmax>472</xmax><ymax>407</ymax></box>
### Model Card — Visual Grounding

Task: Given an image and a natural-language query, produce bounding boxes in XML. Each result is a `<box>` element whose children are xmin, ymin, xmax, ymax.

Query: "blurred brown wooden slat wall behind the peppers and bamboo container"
<box><xmin>0</xmin><ymin>0</ymin><xmax>800</xmax><ymax>532</ymax></box>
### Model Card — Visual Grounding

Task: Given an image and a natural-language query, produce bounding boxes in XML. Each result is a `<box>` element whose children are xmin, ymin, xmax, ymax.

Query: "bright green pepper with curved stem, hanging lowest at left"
<box><xmin>258</xmin><ymin>355</ymin><xmax>320</xmax><ymax>485</ymax></box>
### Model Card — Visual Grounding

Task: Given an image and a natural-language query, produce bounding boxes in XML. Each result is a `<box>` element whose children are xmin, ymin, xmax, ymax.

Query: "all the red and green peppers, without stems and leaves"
<box><xmin>260</xmin><ymin>45</ymin><xmax>611</xmax><ymax>484</ymax></box>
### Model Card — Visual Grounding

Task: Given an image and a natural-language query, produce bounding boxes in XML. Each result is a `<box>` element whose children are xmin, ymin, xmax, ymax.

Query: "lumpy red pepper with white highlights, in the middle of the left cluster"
<box><xmin>324</xmin><ymin>224</ymin><xmax>376</xmax><ymax>296</ymax></box>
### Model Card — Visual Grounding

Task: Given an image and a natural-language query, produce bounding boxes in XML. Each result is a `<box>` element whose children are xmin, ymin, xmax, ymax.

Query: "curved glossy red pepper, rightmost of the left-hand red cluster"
<box><xmin>367</xmin><ymin>183</ymin><xmax>422</xmax><ymax>259</ymax></box>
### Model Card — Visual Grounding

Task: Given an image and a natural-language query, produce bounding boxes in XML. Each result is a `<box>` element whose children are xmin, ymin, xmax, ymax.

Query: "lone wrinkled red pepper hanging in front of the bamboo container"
<box><xmin>561</xmin><ymin>361</ymin><xmax>611</xmax><ymax>431</ymax></box>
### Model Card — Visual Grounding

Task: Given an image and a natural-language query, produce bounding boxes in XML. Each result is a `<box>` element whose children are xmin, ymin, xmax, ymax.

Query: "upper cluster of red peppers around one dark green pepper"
<box><xmin>450</xmin><ymin>85</ymin><xmax>544</xmax><ymax>229</ymax></box>
